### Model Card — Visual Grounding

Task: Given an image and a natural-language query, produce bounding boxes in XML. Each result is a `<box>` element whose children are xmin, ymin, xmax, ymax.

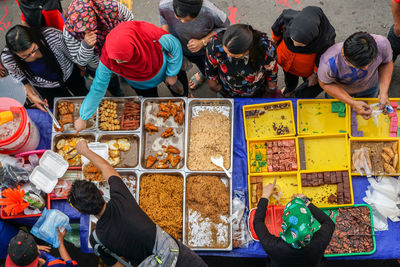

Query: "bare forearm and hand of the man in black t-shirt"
<box><xmin>76</xmin><ymin>141</ymin><xmax>120</xmax><ymax>182</ymax></box>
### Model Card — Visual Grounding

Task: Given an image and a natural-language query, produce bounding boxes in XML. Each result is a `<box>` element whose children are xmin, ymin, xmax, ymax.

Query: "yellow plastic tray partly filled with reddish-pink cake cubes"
<box><xmin>247</xmin><ymin>139</ymin><xmax>300</xmax><ymax>174</ymax></box>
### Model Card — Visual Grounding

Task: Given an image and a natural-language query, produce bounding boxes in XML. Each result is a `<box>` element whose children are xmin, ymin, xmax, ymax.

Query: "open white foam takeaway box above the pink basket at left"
<box><xmin>29</xmin><ymin>150</ymin><xmax>68</xmax><ymax>194</ymax></box>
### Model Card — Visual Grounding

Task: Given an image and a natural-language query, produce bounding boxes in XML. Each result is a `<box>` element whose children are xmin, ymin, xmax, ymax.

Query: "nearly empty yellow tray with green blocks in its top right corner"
<box><xmin>297</xmin><ymin>99</ymin><xmax>350</xmax><ymax>135</ymax></box>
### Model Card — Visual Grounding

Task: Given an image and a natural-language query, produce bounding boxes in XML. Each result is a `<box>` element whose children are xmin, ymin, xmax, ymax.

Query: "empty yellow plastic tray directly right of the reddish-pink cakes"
<box><xmin>298</xmin><ymin>134</ymin><xmax>349</xmax><ymax>171</ymax></box>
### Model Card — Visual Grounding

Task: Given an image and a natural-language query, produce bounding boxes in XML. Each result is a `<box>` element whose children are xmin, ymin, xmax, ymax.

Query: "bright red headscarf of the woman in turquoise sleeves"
<box><xmin>100</xmin><ymin>21</ymin><xmax>168</xmax><ymax>81</ymax></box>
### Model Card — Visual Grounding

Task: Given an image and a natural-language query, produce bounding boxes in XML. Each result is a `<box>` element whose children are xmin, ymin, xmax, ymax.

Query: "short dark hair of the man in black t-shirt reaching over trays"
<box><xmin>68</xmin><ymin>180</ymin><xmax>105</xmax><ymax>215</ymax></box>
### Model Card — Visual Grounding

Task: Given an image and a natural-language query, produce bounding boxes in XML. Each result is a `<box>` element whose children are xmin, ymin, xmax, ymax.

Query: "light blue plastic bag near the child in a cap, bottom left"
<box><xmin>31</xmin><ymin>209</ymin><xmax>71</xmax><ymax>248</ymax></box>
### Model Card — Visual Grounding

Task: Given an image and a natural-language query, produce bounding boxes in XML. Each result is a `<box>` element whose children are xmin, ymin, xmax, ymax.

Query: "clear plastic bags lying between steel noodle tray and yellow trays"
<box><xmin>231</xmin><ymin>190</ymin><xmax>253</xmax><ymax>248</ymax></box>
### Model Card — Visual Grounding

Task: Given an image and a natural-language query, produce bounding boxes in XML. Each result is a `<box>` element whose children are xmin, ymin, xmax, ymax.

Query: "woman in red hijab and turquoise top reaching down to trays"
<box><xmin>75</xmin><ymin>21</ymin><xmax>188</xmax><ymax>132</ymax></box>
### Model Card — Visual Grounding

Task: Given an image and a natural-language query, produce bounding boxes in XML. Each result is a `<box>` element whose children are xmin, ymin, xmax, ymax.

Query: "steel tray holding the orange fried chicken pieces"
<box><xmin>140</xmin><ymin>97</ymin><xmax>187</xmax><ymax>171</ymax></box>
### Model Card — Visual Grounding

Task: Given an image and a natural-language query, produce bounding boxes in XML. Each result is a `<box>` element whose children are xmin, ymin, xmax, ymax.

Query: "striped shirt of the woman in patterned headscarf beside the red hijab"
<box><xmin>63</xmin><ymin>2</ymin><xmax>133</xmax><ymax>70</ymax></box>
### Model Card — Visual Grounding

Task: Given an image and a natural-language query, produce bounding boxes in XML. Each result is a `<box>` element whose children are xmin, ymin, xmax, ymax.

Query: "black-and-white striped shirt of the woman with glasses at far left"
<box><xmin>1</xmin><ymin>28</ymin><xmax>74</xmax><ymax>88</ymax></box>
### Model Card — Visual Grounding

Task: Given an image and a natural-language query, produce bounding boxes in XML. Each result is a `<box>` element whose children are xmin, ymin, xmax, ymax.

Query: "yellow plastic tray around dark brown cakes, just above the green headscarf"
<box><xmin>297</xmin><ymin>169</ymin><xmax>354</xmax><ymax>208</ymax></box>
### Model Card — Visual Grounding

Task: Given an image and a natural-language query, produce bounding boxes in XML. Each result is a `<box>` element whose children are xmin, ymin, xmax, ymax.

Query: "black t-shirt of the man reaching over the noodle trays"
<box><xmin>90</xmin><ymin>176</ymin><xmax>156</xmax><ymax>266</ymax></box>
